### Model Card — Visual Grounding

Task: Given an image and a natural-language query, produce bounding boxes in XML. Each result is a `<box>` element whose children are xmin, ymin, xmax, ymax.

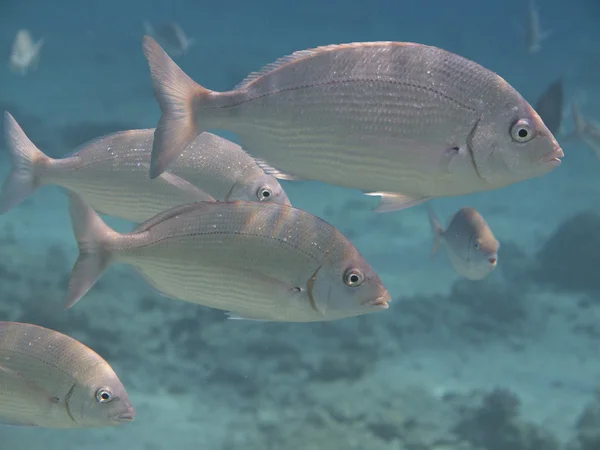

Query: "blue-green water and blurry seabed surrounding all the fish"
<box><xmin>0</xmin><ymin>0</ymin><xmax>600</xmax><ymax>450</ymax></box>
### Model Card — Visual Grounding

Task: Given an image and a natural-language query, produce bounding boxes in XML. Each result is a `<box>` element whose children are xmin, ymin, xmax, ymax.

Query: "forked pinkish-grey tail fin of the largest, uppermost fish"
<box><xmin>144</xmin><ymin>36</ymin><xmax>212</xmax><ymax>178</ymax></box>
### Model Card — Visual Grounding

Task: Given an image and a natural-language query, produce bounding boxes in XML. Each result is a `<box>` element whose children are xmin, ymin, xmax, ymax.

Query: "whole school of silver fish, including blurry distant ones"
<box><xmin>0</xmin><ymin>26</ymin><xmax>568</xmax><ymax>428</ymax></box>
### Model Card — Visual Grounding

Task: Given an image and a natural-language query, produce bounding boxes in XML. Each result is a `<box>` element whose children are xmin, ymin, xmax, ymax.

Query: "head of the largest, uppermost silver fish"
<box><xmin>469</xmin><ymin>92</ymin><xmax>564</xmax><ymax>188</ymax></box>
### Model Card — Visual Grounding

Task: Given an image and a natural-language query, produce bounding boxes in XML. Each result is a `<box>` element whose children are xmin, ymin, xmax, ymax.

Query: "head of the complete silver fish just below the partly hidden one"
<box><xmin>309</xmin><ymin>248</ymin><xmax>391</xmax><ymax>319</ymax></box>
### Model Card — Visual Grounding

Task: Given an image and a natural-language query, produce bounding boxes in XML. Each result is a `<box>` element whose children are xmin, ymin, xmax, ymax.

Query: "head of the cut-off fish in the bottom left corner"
<box><xmin>67</xmin><ymin>364</ymin><xmax>135</xmax><ymax>427</ymax></box>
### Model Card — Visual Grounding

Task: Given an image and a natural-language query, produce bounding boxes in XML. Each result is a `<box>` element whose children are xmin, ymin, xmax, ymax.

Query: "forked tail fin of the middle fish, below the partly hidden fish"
<box><xmin>65</xmin><ymin>192</ymin><xmax>119</xmax><ymax>309</ymax></box>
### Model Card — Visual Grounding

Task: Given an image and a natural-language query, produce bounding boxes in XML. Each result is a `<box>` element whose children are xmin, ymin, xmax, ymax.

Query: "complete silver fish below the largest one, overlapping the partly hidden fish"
<box><xmin>67</xmin><ymin>193</ymin><xmax>390</xmax><ymax>322</ymax></box>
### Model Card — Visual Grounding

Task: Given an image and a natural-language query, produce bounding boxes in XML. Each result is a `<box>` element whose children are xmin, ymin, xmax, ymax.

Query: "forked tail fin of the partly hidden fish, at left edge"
<box><xmin>0</xmin><ymin>111</ymin><xmax>50</xmax><ymax>214</ymax></box>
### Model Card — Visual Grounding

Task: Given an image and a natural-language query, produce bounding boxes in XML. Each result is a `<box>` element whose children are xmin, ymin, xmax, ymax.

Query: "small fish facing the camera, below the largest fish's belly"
<box><xmin>428</xmin><ymin>208</ymin><xmax>500</xmax><ymax>280</ymax></box>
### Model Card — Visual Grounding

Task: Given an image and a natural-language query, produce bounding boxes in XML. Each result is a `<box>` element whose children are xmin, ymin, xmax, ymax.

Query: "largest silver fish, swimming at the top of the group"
<box><xmin>144</xmin><ymin>36</ymin><xmax>564</xmax><ymax>211</ymax></box>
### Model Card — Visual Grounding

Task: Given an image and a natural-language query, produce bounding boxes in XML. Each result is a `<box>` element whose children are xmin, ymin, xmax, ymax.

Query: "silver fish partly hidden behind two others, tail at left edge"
<box><xmin>0</xmin><ymin>112</ymin><xmax>289</xmax><ymax>222</ymax></box>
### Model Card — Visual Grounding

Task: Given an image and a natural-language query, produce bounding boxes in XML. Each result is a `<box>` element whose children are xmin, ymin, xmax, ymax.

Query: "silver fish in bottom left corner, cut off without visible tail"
<box><xmin>0</xmin><ymin>322</ymin><xmax>135</xmax><ymax>428</ymax></box>
